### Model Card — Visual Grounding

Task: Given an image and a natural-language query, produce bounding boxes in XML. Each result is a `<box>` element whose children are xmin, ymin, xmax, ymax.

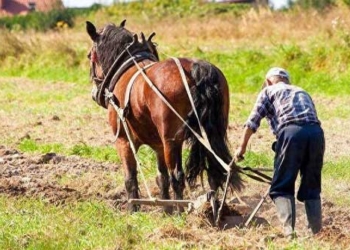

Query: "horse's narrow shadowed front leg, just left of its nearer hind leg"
<box><xmin>156</xmin><ymin>149</ymin><xmax>173</xmax><ymax>214</ymax></box>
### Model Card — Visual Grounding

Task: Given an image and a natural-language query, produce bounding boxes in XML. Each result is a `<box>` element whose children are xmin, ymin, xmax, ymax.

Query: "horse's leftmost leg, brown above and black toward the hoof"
<box><xmin>116</xmin><ymin>138</ymin><xmax>140</xmax><ymax>212</ymax></box>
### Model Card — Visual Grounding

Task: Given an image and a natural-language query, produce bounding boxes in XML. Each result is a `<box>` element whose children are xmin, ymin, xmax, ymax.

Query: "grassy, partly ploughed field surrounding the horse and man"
<box><xmin>0</xmin><ymin>2</ymin><xmax>350</xmax><ymax>249</ymax></box>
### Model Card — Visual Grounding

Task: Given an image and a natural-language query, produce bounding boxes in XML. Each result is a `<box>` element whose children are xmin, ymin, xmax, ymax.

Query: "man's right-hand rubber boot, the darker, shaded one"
<box><xmin>304</xmin><ymin>200</ymin><xmax>322</xmax><ymax>234</ymax></box>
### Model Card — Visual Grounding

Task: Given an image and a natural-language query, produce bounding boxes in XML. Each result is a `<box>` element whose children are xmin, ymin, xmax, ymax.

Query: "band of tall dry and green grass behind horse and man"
<box><xmin>0</xmin><ymin>0</ymin><xmax>350</xmax><ymax>95</ymax></box>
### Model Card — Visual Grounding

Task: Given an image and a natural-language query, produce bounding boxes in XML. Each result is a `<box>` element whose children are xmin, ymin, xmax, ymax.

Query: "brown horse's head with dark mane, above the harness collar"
<box><xmin>86</xmin><ymin>20</ymin><xmax>159</xmax><ymax>107</ymax></box>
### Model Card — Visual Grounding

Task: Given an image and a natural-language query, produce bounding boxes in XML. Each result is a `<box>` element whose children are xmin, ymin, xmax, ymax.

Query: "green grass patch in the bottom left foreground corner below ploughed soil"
<box><xmin>0</xmin><ymin>195</ymin><xmax>185</xmax><ymax>250</ymax></box>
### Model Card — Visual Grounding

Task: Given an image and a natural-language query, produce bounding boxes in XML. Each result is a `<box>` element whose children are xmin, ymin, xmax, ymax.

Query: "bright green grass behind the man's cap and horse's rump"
<box><xmin>194</xmin><ymin>48</ymin><xmax>350</xmax><ymax>96</ymax></box>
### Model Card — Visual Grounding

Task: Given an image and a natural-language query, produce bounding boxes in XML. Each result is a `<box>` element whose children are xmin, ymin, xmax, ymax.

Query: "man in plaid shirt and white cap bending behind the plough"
<box><xmin>235</xmin><ymin>67</ymin><xmax>325</xmax><ymax>239</ymax></box>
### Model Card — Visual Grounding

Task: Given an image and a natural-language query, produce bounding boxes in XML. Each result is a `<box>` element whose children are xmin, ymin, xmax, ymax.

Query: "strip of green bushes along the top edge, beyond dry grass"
<box><xmin>0</xmin><ymin>0</ymin><xmax>350</xmax><ymax>31</ymax></box>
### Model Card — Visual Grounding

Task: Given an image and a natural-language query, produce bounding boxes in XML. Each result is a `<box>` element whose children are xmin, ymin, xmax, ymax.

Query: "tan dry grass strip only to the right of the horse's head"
<box><xmin>105</xmin><ymin>8</ymin><xmax>350</xmax><ymax>49</ymax></box>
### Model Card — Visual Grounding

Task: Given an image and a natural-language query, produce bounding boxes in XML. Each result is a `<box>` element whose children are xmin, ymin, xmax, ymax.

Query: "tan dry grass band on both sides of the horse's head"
<box><xmin>0</xmin><ymin>7</ymin><xmax>350</xmax><ymax>63</ymax></box>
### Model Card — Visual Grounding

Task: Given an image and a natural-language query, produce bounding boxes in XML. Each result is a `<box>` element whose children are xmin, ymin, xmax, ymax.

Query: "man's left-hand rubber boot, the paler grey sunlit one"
<box><xmin>273</xmin><ymin>196</ymin><xmax>295</xmax><ymax>239</ymax></box>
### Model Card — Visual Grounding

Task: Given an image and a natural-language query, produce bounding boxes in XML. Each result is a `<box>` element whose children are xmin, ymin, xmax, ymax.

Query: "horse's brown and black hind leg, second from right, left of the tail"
<box><xmin>164</xmin><ymin>141</ymin><xmax>185</xmax><ymax>212</ymax></box>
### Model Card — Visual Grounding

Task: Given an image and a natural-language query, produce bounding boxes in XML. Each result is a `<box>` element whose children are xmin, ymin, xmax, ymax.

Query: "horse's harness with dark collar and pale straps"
<box><xmin>91</xmin><ymin>35</ymin><xmax>272</xmax><ymax>195</ymax></box>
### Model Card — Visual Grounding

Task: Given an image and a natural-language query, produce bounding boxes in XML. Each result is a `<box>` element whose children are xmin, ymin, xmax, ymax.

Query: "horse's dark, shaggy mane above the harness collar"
<box><xmin>97</xmin><ymin>24</ymin><xmax>159</xmax><ymax>71</ymax></box>
